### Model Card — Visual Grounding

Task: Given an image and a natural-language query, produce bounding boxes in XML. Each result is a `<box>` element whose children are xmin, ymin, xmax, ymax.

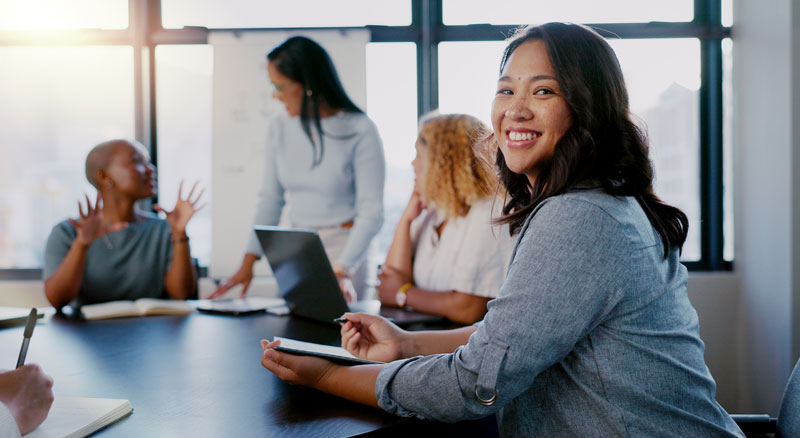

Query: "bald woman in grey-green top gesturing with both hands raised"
<box><xmin>44</xmin><ymin>140</ymin><xmax>202</xmax><ymax>308</ymax></box>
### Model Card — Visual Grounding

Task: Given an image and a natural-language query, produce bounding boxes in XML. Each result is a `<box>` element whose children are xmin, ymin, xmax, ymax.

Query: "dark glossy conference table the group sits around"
<box><xmin>0</xmin><ymin>313</ymin><xmax>496</xmax><ymax>437</ymax></box>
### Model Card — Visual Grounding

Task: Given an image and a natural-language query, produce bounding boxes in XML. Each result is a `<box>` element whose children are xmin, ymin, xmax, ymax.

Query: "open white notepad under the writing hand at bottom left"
<box><xmin>25</xmin><ymin>397</ymin><xmax>133</xmax><ymax>438</ymax></box>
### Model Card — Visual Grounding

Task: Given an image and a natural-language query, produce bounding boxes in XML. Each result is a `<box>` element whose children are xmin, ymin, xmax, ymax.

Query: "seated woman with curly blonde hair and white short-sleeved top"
<box><xmin>378</xmin><ymin>114</ymin><xmax>514</xmax><ymax>324</ymax></box>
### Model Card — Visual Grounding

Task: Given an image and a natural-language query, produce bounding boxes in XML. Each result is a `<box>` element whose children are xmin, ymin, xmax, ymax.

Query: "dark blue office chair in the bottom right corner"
<box><xmin>731</xmin><ymin>359</ymin><xmax>800</xmax><ymax>438</ymax></box>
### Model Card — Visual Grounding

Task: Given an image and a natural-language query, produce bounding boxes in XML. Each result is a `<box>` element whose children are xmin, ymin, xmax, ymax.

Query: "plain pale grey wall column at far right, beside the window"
<box><xmin>732</xmin><ymin>0</ymin><xmax>800</xmax><ymax>415</ymax></box>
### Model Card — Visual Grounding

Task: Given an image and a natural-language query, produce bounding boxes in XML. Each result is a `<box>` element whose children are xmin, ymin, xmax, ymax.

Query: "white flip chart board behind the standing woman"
<box><xmin>208</xmin><ymin>29</ymin><xmax>370</xmax><ymax>277</ymax></box>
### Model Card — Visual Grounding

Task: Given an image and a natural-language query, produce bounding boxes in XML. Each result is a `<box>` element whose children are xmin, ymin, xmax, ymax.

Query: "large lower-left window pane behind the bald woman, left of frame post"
<box><xmin>0</xmin><ymin>46</ymin><xmax>134</xmax><ymax>269</ymax></box>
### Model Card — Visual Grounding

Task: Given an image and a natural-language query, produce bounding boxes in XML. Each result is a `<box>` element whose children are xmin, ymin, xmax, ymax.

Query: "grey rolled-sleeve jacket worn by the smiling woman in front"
<box><xmin>375</xmin><ymin>189</ymin><xmax>743</xmax><ymax>437</ymax></box>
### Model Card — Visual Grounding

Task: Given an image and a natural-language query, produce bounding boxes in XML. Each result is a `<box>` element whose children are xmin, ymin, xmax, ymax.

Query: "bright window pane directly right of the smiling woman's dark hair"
<box><xmin>610</xmin><ymin>39</ymin><xmax>701</xmax><ymax>261</ymax></box>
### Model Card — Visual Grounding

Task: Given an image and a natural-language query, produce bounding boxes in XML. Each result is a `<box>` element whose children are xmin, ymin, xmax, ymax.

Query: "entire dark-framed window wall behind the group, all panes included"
<box><xmin>0</xmin><ymin>0</ymin><xmax>734</xmax><ymax>277</ymax></box>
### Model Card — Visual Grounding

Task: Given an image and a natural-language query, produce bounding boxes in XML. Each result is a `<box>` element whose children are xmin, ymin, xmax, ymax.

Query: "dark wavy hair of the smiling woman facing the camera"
<box><xmin>496</xmin><ymin>23</ymin><xmax>689</xmax><ymax>258</ymax></box>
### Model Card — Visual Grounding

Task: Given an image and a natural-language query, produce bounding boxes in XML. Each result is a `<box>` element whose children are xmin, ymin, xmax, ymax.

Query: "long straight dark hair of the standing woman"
<box><xmin>267</xmin><ymin>36</ymin><xmax>364</xmax><ymax>166</ymax></box>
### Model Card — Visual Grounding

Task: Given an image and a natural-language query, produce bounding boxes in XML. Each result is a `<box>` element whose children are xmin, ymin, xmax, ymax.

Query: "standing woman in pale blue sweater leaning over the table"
<box><xmin>211</xmin><ymin>37</ymin><xmax>386</xmax><ymax>300</ymax></box>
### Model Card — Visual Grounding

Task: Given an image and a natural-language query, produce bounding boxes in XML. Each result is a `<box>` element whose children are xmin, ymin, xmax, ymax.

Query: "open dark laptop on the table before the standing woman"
<box><xmin>254</xmin><ymin>226</ymin><xmax>445</xmax><ymax>326</ymax></box>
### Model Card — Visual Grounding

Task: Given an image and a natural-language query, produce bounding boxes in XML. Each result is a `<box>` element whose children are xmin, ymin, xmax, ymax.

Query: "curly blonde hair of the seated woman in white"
<box><xmin>419</xmin><ymin>114</ymin><xmax>498</xmax><ymax>220</ymax></box>
